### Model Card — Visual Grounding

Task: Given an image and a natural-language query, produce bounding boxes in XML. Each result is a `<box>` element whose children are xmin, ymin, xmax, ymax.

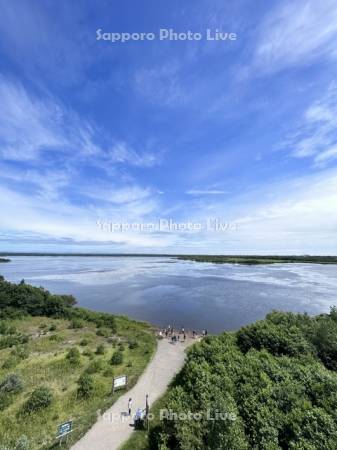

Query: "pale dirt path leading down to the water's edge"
<box><xmin>72</xmin><ymin>338</ymin><xmax>195</xmax><ymax>450</ymax></box>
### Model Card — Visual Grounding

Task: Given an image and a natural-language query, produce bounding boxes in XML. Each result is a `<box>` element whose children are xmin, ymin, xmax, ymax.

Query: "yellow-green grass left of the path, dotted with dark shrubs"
<box><xmin>0</xmin><ymin>316</ymin><xmax>156</xmax><ymax>450</ymax></box>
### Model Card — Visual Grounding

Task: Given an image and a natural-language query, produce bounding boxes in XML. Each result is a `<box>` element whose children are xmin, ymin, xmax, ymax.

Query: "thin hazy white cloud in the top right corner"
<box><xmin>254</xmin><ymin>0</ymin><xmax>337</xmax><ymax>72</ymax></box>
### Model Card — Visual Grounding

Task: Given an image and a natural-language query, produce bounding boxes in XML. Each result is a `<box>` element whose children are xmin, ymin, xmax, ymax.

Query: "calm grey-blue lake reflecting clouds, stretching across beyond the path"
<box><xmin>0</xmin><ymin>256</ymin><xmax>337</xmax><ymax>333</ymax></box>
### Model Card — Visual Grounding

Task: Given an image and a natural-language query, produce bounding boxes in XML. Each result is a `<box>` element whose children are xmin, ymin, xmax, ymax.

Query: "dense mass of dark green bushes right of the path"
<box><xmin>150</xmin><ymin>309</ymin><xmax>337</xmax><ymax>450</ymax></box>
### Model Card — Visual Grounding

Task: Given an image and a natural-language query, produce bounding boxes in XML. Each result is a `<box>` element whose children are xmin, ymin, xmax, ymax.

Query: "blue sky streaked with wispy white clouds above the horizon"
<box><xmin>0</xmin><ymin>0</ymin><xmax>337</xmax><ymax>254</ymax></box>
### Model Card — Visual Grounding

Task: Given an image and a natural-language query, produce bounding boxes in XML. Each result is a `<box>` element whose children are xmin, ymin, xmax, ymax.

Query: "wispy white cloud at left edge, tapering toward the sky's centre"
<box><xmin>0</xmin><ymin>76</ymin><xmax>163</xmax><ymax>171</ymax></box>
